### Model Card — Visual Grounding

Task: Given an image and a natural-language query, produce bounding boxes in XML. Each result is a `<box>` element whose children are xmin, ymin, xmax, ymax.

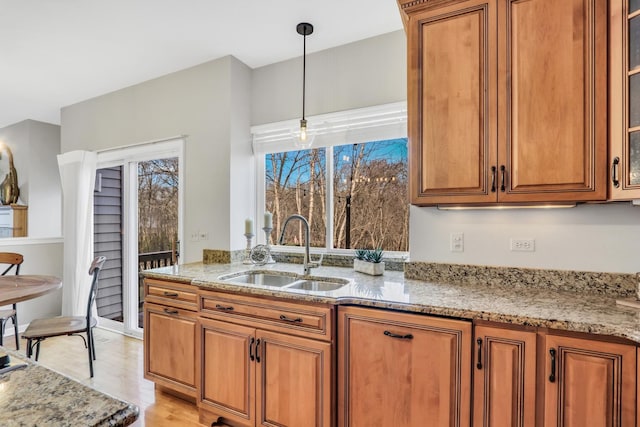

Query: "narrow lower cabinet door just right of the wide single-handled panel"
<box><xmin>473</xmin><ymin>326</ymin><xmax>536</xmax><ymax>427</ymax></box>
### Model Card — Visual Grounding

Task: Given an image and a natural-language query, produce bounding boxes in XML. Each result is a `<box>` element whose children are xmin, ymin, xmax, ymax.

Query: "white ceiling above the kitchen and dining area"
<box><xmin>0</xmin><ymin>0</ymin><xmax>402</xmax><ymax>128</ymax></box>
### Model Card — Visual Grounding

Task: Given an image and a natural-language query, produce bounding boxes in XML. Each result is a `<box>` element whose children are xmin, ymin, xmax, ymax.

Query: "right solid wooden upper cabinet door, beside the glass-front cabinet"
<box><xmin>498</xmin><ymin>0</ymin><xmax>607</xmax><ymax>202</ymax></box>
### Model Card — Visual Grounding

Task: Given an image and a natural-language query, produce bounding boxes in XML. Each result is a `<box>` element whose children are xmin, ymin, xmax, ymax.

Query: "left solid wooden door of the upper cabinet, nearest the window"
<box><xmin>409</xmin><ymin>0</ymin><xmax>496</xmax><ymax>204</ymax></box>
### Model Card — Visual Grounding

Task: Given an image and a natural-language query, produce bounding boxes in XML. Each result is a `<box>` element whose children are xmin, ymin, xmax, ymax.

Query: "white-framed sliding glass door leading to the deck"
<box><xmin>94</xmin><ymin>140</ymin><xmax>183</xmax><ymax>337</ymax></box>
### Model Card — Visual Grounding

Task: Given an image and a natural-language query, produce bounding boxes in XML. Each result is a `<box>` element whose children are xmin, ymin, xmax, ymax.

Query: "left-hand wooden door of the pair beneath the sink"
<box><xmin>199</xmin><ymin>319</ymin><xmax>255</xmax><ymax>424</ymax></box>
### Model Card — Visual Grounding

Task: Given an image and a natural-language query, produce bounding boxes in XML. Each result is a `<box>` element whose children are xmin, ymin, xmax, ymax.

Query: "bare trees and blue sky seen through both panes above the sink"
<box><xmin>265</xmin><ymin>138</ymin><xmax>409</xmax><ymax>251</ymax></box>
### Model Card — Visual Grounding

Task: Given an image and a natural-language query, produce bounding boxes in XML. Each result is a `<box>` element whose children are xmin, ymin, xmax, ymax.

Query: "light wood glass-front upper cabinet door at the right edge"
<box><xmin>609</xmin><ymin>0</ymin><xmax>640</xmax><ymax>200</ymax></box>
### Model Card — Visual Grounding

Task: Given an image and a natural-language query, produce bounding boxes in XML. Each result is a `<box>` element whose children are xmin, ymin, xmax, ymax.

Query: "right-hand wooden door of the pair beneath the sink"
<box><xmin>256</xmin><ymin>331</ymin><xmax>332</xmax><ymax>427</ymax></box>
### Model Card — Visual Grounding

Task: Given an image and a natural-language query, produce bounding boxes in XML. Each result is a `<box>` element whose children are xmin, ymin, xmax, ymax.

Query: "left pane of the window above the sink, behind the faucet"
<box><xmin>265</xmin><ymin>148</ymin><xmax>327</xmax><ymax>248</ymax></box>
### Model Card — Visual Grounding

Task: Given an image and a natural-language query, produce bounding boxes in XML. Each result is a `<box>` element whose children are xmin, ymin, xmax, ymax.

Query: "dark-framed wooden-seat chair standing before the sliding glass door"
<box><xmin>22</xmin><ymin>256</ymin><xmax>106</xmax><ymax>378</ymax></box>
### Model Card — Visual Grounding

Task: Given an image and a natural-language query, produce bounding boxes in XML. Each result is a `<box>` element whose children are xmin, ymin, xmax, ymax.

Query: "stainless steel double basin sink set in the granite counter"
<box><xmin>218</xmin><ymin>270</ymin><xmax>349</xmax><ymax>292</ymax></box>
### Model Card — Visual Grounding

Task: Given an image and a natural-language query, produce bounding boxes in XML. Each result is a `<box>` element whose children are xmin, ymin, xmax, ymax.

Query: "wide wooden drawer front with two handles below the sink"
<box><xmin>200</xmin><ymin>291</ymin><xmax>333</xmax><ymax>340</ymax></box>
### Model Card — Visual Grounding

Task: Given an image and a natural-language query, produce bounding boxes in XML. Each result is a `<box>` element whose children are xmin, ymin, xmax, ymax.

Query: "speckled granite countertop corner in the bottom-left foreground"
<box><xmin>0</xmin><ymin>347</ymin><xmax>138</xmax><ymax>427</ymax></box>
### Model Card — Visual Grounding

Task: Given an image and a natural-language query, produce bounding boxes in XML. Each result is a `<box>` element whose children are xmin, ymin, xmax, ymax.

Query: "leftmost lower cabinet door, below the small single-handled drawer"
<box><xmin>144</xmin><ymin>303</ymin><xmax>197</xmax><ymax>397</ymax></box>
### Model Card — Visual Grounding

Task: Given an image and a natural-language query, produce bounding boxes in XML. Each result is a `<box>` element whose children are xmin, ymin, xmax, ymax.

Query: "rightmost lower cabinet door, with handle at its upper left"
<box><xmin>542</xmin><ymin>335</ymin><xmax>637</xmax><ymax>427</ymax></box>
